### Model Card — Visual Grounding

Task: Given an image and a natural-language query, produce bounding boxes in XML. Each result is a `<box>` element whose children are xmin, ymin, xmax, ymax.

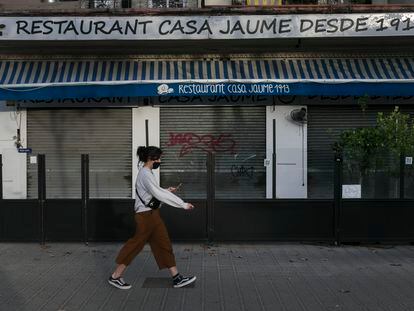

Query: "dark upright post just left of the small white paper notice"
<box><xmin>334</xmin><ymin>154</ymin><xmax>342</xmax><ymax>246</ymax></box>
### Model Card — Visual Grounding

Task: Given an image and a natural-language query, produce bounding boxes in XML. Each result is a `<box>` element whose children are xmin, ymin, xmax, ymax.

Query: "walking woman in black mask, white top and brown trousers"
<box><xmin>108</xmin><ymin>146</ymin><xmax>196</xmax><ymax>289</ymax></box>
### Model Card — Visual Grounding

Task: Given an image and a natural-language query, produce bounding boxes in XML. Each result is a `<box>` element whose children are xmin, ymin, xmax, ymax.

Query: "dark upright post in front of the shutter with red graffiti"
<box><xmin>207</xmin><ymin>152</ymin><xmax>215</xmax><ymax>242</ymax></box>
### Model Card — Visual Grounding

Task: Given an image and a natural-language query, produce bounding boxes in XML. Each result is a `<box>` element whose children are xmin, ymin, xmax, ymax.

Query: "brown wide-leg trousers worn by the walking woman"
<box><xmin>116</xmin><ymin>209</ymin><xmax>176</xmax><ymax>270</ymax></box>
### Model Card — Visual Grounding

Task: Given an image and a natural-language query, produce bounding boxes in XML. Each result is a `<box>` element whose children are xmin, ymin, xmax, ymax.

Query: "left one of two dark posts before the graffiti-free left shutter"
<box><xmin>37</xmin><ymin>154</ymin><xmax>46</xmax><ymax>245</ymax></box>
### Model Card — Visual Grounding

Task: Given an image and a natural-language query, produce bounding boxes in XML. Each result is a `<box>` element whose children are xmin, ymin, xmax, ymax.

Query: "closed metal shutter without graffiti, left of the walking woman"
<box><xmin>27</xmin><ymin>109</ymin><xmax>132</xmax><ymax>198</ymax></box>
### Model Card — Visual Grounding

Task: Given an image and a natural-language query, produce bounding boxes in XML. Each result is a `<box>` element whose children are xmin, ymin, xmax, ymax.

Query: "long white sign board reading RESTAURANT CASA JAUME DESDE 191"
<box><xmin>0</xmin><ymin>13</ymin><xmax>414</xmax><ymax>40</ymax></box>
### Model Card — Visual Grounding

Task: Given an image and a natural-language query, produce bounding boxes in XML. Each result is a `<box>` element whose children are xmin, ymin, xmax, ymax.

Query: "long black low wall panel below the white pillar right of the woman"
<box><xmin>214</xmin><ymin>200</ymin><xmax>334</xmax><ymax>241</ymax></box>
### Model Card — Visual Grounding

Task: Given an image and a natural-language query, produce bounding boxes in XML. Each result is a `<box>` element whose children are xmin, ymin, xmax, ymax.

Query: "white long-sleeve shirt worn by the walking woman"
<box><xmin>135</xmin><ymin>166</ymin><xmax>187</xmax><ymax>213</ymax></box>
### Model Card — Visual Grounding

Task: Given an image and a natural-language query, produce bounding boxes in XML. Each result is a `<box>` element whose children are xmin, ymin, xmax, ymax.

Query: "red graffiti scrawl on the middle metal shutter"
<box><xmin>167</xmin><ymin>133</ymin><xmax>236</xmax><ymax>157</ymax></box>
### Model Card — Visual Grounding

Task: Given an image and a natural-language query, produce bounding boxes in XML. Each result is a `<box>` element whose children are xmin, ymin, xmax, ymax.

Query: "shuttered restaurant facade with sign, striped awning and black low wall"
<box><xmin>0</xmin><ymin>6</ymin><xmax>414</xmax><ymax>243</ymax></box>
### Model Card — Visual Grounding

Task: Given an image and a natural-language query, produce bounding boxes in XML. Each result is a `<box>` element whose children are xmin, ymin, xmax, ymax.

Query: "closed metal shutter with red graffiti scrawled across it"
<box><xmin>160</xmin><ymin>106</ymin><xmax>266</xmax><ymax>199</ymax></box>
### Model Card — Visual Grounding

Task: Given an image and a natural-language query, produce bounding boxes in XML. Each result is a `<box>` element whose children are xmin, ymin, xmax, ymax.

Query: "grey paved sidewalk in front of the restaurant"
<box><xmin>0</xmin><ymin>243</ymin><xmax>414</xmax><ymax>311</ymax></box>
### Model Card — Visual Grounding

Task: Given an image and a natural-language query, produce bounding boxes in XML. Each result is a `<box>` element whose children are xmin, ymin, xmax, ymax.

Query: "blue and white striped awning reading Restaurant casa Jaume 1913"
<box><xmin>0</xmin><ymin>57</ymin><xmax>414</xmax><ymax>100</ymax></box>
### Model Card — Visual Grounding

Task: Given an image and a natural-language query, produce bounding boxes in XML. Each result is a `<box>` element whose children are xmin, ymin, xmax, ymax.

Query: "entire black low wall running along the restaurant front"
<box><xmin>0</xmin><ymin>199</ymin><xmax>414</xmax><ymax>242</ymax></box>
